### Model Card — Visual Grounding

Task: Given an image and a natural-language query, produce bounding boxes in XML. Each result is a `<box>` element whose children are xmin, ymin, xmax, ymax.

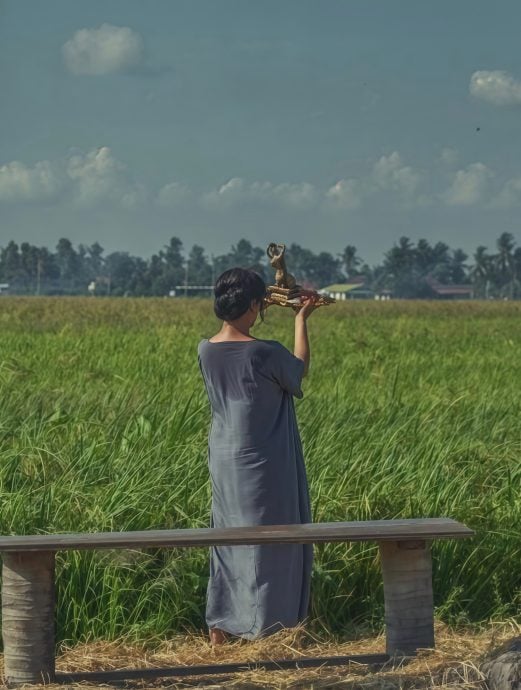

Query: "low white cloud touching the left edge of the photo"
<box><xmin>0</xmin><ymin>161</ymin><xmax>62</xmax><ymax>202</ymax></box>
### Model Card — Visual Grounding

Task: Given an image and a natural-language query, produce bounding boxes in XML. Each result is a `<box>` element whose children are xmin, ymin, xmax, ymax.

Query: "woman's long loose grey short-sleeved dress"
<box><xmin>198</xmin><ymin>340</ymin><xmax>313</xmax><ymax>639</ymax></box>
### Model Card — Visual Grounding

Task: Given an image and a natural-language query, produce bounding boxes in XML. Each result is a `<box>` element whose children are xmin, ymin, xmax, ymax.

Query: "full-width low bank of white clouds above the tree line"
<box><xmin>6</xmin><ymin>146</ymin><xmax>521</xmax><ymax>212</ymax></box>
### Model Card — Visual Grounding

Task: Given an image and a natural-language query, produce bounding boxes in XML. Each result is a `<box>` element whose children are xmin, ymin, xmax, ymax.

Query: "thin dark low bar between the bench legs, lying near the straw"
<box><xmin>56</xmin><ymin>654</ymin><xmax>389</xmax><ymax>683</ymax></box>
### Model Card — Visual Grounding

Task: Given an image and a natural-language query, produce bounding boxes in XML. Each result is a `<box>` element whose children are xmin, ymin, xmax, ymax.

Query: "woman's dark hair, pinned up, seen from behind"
<box><xmin>213</xmin><ymin>268</ymin><xmax>266</xmax><ymax>321</ymax></box>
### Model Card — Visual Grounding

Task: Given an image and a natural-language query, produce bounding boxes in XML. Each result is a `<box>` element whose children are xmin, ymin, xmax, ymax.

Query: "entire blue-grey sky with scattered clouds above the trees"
<box><xmin>0</xmin><ymin>0</ymin><xmax>521</xmax><ymax>263</ymax></box>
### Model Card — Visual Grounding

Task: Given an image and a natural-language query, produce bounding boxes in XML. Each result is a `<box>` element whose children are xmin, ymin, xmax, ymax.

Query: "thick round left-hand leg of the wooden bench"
<box><xmin>2</xmin><ymin>551</ymin><xmax>54</xmax><ymax>686</ymax></box>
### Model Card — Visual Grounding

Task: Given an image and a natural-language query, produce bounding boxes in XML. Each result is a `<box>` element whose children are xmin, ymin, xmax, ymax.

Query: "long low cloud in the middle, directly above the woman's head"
<box><xmin>203</xmin><ymin>177</ymin><xmax>318</xmax><ymax>209</ymax></box>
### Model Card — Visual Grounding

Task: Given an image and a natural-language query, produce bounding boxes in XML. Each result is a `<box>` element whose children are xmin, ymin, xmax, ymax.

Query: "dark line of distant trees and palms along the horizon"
<box><xmin>0</xmin><ymin>232</ymin><xmax>521</xmax><ymax>299</ymax></box>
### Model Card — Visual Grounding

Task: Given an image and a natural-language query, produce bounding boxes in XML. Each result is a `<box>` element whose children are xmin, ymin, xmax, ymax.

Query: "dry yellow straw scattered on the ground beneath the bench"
<box><xmin>2</xmin><ymin>622</ymin><xmax>521</xmax><ymax>690</ymax></box>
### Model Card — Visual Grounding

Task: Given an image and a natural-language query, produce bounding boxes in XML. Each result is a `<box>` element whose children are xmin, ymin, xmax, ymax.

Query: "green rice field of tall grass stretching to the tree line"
<box><xmin>0</xmin><ymin>298</ymin><xmax>521</xmax><ymax>642</ymax></box>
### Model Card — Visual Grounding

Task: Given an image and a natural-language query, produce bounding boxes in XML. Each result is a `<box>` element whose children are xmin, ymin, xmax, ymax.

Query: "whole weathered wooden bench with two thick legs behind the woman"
<box><xmin>0</xmin><ymin>518</ymin><xmax>474</xmax><ymax>685</ymax></box>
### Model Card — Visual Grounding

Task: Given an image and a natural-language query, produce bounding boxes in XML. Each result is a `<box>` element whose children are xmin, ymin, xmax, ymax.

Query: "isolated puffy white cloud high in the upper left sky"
<box><xmin>62</xmin><ymin>24</ymin><xmax>143</xmax><ymax>74</ymax></box>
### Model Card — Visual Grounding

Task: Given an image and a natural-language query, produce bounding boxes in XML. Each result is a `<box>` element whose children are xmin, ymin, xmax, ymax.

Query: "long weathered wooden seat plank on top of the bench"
<box><xmin>0</xmin><ymin>518</ymin><xmax>474</xmax><ymax>553</ymax></box>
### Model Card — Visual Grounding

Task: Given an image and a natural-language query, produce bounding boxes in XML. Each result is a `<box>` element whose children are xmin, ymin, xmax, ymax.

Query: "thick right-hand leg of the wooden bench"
<box><xmin>380</xmin><ymin>541</ymin><xmax>434</xmax><ymax>656</ymax></box>
